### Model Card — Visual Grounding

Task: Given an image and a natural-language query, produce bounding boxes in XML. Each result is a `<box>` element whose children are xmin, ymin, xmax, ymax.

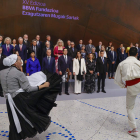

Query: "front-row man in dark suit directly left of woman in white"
<box><xmin>58</xmin><ymin>48</ymin><xmax>72</xmax><ymax>95</ymax></box>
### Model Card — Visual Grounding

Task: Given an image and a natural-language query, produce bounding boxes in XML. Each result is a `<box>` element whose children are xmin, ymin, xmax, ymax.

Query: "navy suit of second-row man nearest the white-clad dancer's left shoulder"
<box><xmin>108</xmin><ymin>51</ymin><xmax>117</xmax><ymax>77</ymax></box>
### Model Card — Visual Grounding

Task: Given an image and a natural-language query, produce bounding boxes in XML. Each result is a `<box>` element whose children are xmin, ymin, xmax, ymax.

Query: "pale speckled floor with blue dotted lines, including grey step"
<box><xmin>0</xmin><ymin>79</ymin><xmax>140</xmax><ymax>140</ymax></box>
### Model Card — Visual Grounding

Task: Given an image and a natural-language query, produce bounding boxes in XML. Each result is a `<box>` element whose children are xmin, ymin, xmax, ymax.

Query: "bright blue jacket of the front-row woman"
<box><xmin>26</xmin><ymin>57</ymin><xmax>41</xmax><ymax>75</ymax></box>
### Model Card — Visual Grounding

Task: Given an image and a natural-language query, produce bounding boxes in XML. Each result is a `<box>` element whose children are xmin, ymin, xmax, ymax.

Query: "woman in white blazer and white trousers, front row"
<box><xmin>73</xmin><ymin>51</ymin><xmax>86</xmax><ymax>95</ymax></box>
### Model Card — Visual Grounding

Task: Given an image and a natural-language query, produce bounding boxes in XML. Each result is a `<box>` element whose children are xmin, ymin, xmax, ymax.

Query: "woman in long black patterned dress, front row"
<box><xmin>84</xmin><ymin>53</ymin><xmax>96</xmax><ymax>93</ymax></box>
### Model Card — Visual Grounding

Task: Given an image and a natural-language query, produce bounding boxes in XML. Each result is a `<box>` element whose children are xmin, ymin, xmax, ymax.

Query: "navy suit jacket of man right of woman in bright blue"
<box><xmin>42</xmin><ymin>56</ymin><xmax>55</xmax><ymax>73</ymax></box>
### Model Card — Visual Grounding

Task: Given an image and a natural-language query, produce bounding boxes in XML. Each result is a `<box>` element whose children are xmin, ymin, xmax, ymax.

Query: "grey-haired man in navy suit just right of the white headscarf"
<box><xmin>15</xmin><ymin>37</ymin><xmax>27</xmax><ymax>72</ymax></box>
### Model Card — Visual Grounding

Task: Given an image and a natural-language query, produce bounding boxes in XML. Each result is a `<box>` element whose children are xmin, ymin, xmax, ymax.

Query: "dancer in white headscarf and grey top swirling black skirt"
<box><xmin>0</xmin><ymin>54</ymin><xmax>61</xmax><ymax>140</ymax></box>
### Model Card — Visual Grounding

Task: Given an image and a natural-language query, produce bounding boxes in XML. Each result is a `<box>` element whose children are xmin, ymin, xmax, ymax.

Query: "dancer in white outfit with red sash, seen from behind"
<box><xmin>115</xmin><ymin>47</ymin><xmax>140</xmax><ymax>137</ymax></box>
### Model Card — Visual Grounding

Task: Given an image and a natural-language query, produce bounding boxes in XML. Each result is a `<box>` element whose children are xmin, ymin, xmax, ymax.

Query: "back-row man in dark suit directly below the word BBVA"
<box><xmin>23</xmin><ymin>34</ymin><xmax>30</xmax><ymax>59</ymax></box>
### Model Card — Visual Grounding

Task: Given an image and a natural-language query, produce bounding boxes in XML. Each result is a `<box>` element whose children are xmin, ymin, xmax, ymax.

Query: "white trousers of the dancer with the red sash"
<box><xmin>126</xmin><ymin>83</ymin><xmax>140</xmax><ymax>129</ymax></box>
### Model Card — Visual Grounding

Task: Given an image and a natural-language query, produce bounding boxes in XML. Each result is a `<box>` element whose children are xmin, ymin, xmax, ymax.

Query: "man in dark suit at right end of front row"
<box><xmin>96</xmin><ymin>51</ymin><xmax>107</xmax><ymax>93</ymax></box>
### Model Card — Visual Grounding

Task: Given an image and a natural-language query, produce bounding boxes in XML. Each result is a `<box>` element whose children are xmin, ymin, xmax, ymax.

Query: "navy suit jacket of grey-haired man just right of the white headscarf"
<box><xmin>15</xmin><ymin>45</ymin><xmax>27</xmax><ymax>62</ymax></box>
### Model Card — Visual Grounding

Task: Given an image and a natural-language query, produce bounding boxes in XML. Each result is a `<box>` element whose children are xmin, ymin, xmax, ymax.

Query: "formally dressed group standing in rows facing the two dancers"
<box><xmin>0</xmin><ymin>34</ymin><xmax>140</xmax><ymax>95</ymax></box>
